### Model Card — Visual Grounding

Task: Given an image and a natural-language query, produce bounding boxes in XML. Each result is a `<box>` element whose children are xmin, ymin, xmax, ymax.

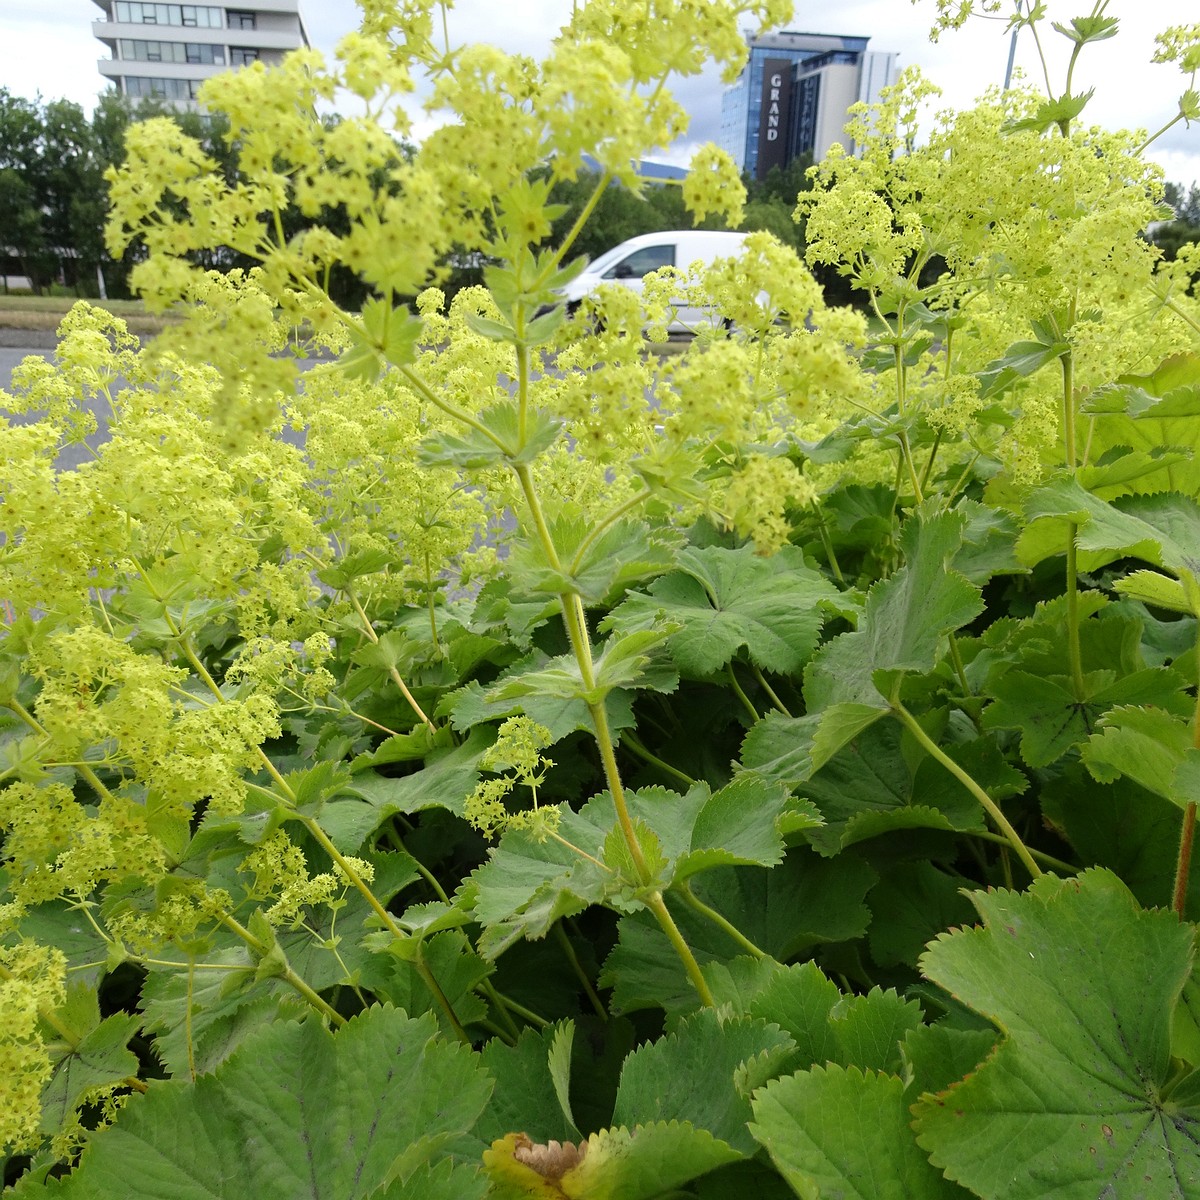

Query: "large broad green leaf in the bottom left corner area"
<box><xmin>56</xmin><ymin>1008</ymin><xmax>492</xmax><ymax>1200</ymax></box>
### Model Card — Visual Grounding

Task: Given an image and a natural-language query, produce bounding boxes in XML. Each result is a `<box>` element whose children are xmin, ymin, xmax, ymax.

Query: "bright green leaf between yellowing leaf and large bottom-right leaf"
<box><xmin>750</xmin><ymin>1067</ymin><xmax>966</xmax><ymax>1200</ymax></box>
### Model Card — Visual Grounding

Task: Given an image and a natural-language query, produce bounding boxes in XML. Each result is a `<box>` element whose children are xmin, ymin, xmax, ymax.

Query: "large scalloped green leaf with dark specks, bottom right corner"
<box><xmin>916</xmin><ymin>870</ymin><xmax>1200</xmax><ymax>1200</ymax></box>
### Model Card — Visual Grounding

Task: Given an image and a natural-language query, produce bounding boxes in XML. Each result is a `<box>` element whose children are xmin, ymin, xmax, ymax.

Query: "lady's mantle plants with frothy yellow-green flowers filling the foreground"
<box><xmin>0</xmin><ymin>0</ymin><xmax>1200</xmax><ymax>1200</ymax></box>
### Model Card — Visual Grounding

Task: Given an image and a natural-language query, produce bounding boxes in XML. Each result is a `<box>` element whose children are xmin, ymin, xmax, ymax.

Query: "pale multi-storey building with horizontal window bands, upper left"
<box><xmin>91</xmin><ymin>0</ymin><xmax>308</xmax><ymax>108</ymax></box>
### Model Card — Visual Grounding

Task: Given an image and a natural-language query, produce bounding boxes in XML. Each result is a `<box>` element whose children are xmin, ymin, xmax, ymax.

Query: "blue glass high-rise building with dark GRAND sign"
<box><xmin>721</xmin><ymin>31</ymin><xmax>896</xmax><ymax>179</ymax></box>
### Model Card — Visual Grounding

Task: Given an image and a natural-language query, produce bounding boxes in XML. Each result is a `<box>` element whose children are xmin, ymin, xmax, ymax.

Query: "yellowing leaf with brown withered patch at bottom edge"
<box><xmin>484</xmin><ymin>1121</ymin><xmax>742</xmax><ymax>1200</ymax></box>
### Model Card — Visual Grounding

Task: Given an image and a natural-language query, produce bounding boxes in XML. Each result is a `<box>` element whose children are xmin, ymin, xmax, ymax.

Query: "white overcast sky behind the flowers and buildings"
<box><xmin>7</xmin><ymin>0</ymin><xmax>1200</xmax><ymax>185</ymax></box>
